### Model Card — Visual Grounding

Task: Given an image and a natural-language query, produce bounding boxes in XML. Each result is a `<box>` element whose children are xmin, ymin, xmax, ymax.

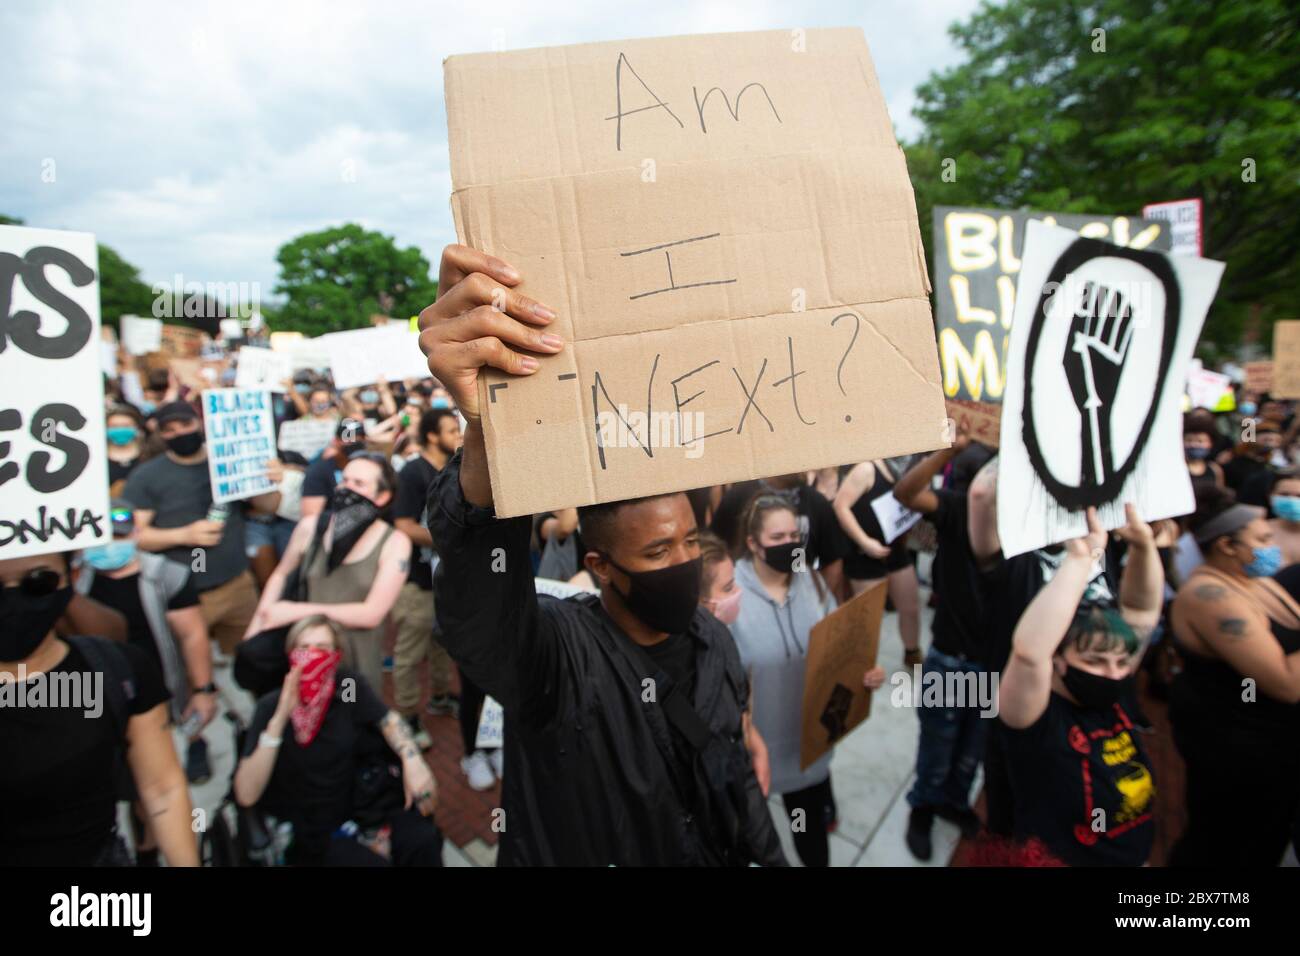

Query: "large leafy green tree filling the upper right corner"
<box><xmin>907</xmin><ymin>0</ymin><xmax>1300</xmax><ymax>347</ymax></box>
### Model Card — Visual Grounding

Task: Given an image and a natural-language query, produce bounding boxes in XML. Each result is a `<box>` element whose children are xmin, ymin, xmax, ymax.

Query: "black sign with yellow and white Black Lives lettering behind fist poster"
<box><xmin>935</xmin><ymin>206</ymin><xmax>1170</xmax><ymax>402</ymax></box>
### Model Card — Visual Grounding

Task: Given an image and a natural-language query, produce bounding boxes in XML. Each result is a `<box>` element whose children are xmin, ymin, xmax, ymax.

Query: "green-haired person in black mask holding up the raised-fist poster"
<box><xmin>998</xmin><ymin>505</ymin><xmax>1159</xmax><ymax>866</ymax></box>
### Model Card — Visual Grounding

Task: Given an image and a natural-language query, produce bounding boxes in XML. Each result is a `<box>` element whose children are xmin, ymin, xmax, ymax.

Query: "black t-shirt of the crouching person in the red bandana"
<box><xmin>243</xmin><ymin>667</ymin><xmax>387</xmax><ymax>853</ymax></box>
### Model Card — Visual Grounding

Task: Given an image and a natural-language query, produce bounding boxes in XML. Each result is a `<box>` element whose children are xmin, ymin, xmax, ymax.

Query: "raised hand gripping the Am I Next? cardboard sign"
<box><xmin>420</xmin><ymin>246</ymin><xmax>564</xmax><ymax>420</ymax></box>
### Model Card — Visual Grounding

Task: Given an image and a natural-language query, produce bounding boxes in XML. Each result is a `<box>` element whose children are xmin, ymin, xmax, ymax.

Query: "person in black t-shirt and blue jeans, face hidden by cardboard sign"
<box><xmin>894</xmin><ymin>429</ymin><xmax>992</xmax><ymax>861</ymax></box>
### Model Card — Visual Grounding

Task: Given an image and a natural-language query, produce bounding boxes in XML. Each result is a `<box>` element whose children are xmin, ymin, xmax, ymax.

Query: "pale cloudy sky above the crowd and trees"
<box><xmin>0</xmin><ymin>0</ymin><xmax>976</xmax><ymax>298</ymax></box>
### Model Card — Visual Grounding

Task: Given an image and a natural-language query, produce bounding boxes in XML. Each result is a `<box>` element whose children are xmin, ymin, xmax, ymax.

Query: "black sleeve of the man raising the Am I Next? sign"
<box><xmin>428</xmin><ymin>451</ymin><xmax>560</xmax><ymax>710</ymax></box>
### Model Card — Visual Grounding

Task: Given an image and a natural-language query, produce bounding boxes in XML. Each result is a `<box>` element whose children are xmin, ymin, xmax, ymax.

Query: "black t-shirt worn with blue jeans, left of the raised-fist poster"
<box><xmin>927</xmin><ymin>489</ymin><xmax>988</xmax><ymax>663</ymax></box>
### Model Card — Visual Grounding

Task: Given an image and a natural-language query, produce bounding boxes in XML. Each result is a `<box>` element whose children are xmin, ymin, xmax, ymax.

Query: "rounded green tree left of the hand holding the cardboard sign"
<box><xmin>276</xmin><ymin>222</ymin><xmax>437</xmax><ymax>336</ymax></box>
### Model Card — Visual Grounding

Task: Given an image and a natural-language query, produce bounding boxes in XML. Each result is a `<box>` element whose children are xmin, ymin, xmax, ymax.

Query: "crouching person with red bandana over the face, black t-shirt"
<box><xmin>234</xmin><ymin>614</ymin><xmax>442</xmax><ymax>866</ymax></box>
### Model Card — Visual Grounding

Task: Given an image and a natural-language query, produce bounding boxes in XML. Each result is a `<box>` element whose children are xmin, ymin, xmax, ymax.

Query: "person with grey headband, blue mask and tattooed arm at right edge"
<box><xmin>1170</xmin><ymin>489</ymin><xmax>1300</xmax><ymax>866</ymax></box>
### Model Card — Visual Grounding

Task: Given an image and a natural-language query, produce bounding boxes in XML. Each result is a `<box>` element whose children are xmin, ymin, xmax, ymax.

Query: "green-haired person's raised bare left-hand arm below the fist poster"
<box><xmin>998</xmin><ymin>509</ymin><xmax>1106</xmax><ymax>728</ymax></box>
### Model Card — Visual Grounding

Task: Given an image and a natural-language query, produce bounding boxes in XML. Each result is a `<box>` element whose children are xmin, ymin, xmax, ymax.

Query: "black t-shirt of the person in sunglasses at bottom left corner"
<box><xmin>0</xmin><ymin>644</ymin><xmax>169</xmax><ymax>866</ymax></box>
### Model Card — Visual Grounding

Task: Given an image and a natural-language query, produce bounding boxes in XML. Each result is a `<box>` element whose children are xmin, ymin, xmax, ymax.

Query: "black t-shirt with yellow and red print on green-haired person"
<box><xmin>1001</xmin><ymin>693</ymin><xmax>1156</xmax><ymax>866</ymax></box>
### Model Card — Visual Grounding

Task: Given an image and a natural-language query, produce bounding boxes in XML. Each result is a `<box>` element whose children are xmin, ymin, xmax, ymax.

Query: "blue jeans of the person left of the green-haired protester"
<box><xmin>907</xmin><ymin>648</ymin><xmax>997</xmax><ymax>809</ymax></box>
